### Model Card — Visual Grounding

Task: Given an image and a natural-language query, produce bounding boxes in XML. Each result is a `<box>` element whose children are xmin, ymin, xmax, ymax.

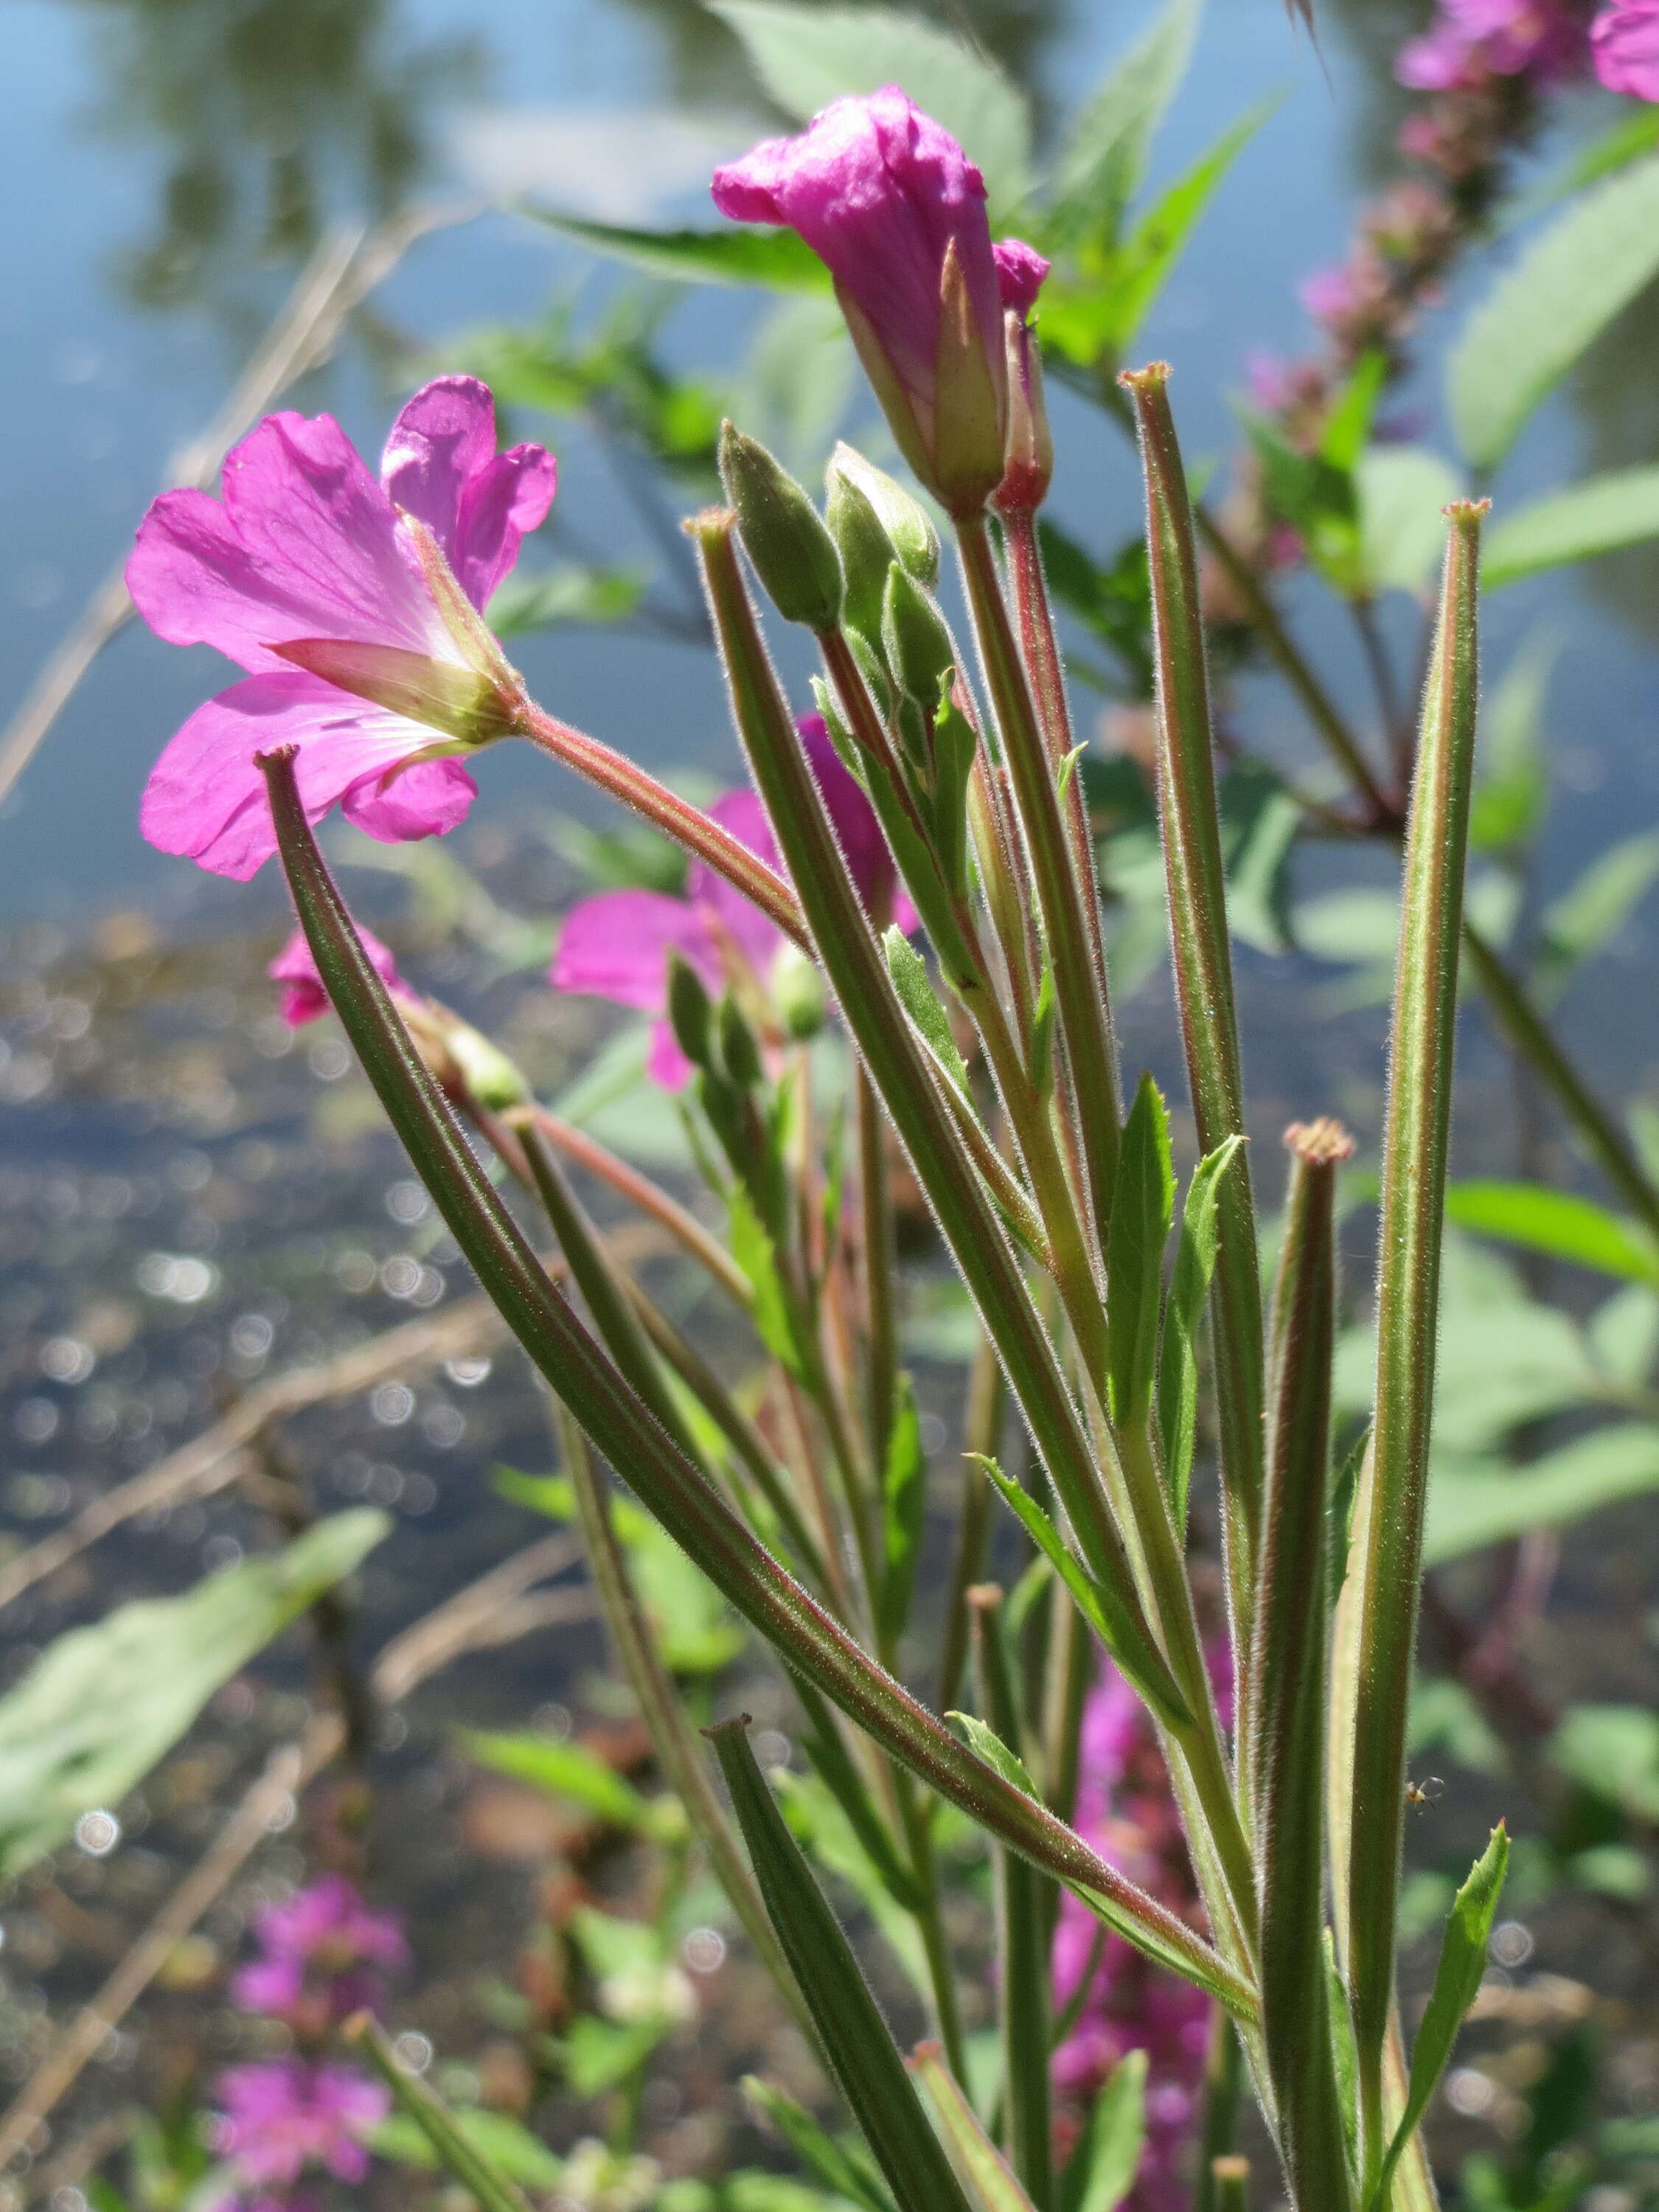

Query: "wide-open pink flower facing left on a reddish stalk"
<box><xmin>126</xmin><ymin>376</ymin><xmax>555</xmax><ymax>880</ymax></box>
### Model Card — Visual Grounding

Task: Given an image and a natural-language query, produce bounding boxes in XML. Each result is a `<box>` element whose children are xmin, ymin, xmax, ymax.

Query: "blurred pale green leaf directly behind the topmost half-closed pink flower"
<box><xmin>708</xmin><ymin>0</ymin><xmax>1031</xmax><ymax>221</ymax></box>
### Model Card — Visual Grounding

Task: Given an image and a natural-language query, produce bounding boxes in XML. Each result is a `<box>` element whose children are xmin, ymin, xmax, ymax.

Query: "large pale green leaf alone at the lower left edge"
<box><xmin>0</xmin><ymin>1509</ymin><xmax>392</xmax><ymax>1880</ymax></box>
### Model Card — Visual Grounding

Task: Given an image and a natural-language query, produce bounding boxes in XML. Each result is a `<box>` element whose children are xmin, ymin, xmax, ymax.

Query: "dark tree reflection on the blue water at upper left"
<box><xmin>75</xmin><ymin>0</ymin><xmax>487</xmax><ymax>341</ymax></box>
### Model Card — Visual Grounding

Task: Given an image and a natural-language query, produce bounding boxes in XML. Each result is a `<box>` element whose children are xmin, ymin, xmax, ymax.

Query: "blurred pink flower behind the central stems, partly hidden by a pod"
<box><xmin>562</xmin><ymin>714</ymin><xmax>916</xmax><ymax>1091</ymax></box>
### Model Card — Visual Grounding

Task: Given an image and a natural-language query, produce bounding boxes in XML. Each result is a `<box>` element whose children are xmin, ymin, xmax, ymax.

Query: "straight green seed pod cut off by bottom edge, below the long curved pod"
<box><xmin>710</xmin><ymin>1719</ymin><xmax>969</xmax><ymax>2212</ymax></box>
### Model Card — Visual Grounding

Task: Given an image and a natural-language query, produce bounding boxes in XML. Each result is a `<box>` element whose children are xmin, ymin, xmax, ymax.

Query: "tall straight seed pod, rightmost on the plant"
<box><xmin>1347</xmin><ymin>502</ymin><xmax>1486</xmax><ymax>2181</ymax></box>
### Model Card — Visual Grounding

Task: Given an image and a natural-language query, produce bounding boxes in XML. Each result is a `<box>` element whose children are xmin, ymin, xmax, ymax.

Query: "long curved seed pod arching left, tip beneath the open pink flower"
<box><xmin>261</xmin><ymin>748</ymin><xmax>1256</xmax><ymax>2017</ymax></box>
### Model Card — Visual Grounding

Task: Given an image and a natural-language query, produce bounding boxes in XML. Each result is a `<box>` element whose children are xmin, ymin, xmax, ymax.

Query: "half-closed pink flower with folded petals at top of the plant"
<box><xmin>714</xmin><ymin>84</ymin><xmax>1022</xmax><ymax>511</ymax></box>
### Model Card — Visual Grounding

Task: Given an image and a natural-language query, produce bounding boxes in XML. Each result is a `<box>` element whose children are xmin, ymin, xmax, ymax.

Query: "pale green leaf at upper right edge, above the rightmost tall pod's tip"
<box><xmin>1447</xmin><ymin>159</ymin><xmax>1659</xmax><ymax>469</ymax></box>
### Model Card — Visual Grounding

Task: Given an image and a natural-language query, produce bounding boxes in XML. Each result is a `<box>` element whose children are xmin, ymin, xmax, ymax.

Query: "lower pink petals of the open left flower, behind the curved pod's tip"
<box><xmin>139</xmin><ymin>668</ymin><xmax>476</xmax><ymax>883</ymax></box>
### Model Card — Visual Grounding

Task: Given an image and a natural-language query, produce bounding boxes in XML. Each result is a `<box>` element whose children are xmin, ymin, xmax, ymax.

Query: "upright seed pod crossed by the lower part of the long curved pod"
<box><xmin>973</xmin><ymin>1584</ymin><xmax>1053</xmax><ymax>2212</ymax></box>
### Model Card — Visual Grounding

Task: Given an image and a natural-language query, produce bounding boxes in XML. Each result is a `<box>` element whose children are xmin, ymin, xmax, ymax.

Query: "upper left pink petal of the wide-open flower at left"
<box><xmin>126</xmin><ymin>414</ymin><xmax>458</xmax><ymax>672</ymax></box>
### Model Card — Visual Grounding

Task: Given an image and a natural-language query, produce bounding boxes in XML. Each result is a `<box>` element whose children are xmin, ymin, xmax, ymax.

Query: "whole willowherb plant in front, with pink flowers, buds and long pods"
<box><xmin>128</xmin><ymin>73</ymin><xmax>1506</xmax><ymax>2212</ymax></box>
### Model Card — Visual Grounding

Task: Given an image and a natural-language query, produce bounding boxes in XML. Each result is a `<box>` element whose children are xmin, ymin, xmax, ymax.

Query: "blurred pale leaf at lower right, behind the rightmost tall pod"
<box><xmin>1422</xmin><ymin>1422</ymin><xmax>1659</xmax><ymax>1566</ymax></box>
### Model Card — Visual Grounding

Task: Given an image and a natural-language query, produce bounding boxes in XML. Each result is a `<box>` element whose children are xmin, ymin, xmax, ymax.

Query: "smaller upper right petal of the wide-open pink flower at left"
<box><xmin>380</xmin><ymin>376</ymin><xmax>557</xmax><ymax>608</ymax></box>
